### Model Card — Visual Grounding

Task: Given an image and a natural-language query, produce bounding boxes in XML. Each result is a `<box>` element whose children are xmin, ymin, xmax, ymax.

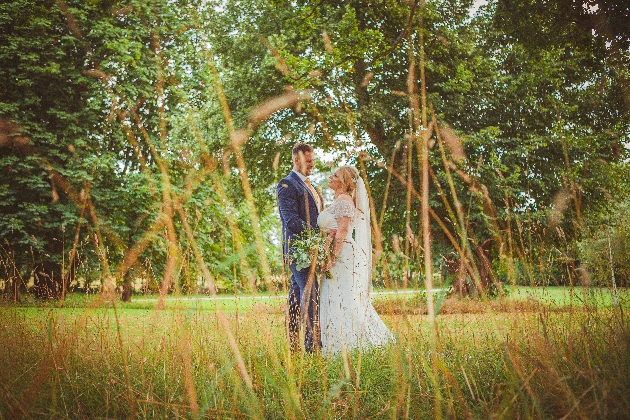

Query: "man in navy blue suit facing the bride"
<box><xmin>276</xmin><ymin>143</ymin><xmax>324</xmax><ymax>353</ymax></box>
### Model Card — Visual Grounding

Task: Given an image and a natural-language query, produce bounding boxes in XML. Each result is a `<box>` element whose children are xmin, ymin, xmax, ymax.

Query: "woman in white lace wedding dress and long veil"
<box><xmin>317</xmin><ymin>166</ymin><xmax>394</xmax><ymax>355</ymax></box>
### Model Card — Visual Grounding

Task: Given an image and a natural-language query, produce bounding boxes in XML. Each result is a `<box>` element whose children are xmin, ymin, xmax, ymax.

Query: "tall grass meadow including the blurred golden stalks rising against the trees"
<box><xmin>0</xmin><ymin>2</ymin><xmax>630</xmax><ymax>419</ymax></box>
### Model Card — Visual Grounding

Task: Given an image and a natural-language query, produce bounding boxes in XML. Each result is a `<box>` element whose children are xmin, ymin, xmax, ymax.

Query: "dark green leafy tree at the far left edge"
<box><xmin>0</xmin><ymin>1</ymin><xmax>107</xmax><ymax>296</ymax></box>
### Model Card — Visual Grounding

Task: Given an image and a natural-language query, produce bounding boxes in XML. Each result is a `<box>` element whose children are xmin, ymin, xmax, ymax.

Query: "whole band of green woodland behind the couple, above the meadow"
<box><xmin>0</xmin><ymin>0</ymin><xmax>630</xmax><ymax>300</ymax></box>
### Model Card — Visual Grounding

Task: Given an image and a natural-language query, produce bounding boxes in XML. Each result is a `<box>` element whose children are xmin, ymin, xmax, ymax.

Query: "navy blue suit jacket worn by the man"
<box><xmin>276</xmin><ymin>171</ymin><xmax>323</xmax><ymax>258</ymax></box>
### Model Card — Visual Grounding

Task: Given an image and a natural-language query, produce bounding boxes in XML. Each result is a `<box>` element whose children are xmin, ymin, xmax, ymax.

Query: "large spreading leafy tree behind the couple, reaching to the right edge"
<box><xmin>204</xmin><ymin>1</ymin><xmax>627</xmax><ymax>294</ymax></box>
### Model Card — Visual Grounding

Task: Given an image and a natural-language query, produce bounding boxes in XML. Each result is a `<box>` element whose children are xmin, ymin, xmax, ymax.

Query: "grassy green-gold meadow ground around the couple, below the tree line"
<box><xmin>0</xmin><ymin>287</ymin><xmax>630</xmax><ymax>419</ymax></box>
